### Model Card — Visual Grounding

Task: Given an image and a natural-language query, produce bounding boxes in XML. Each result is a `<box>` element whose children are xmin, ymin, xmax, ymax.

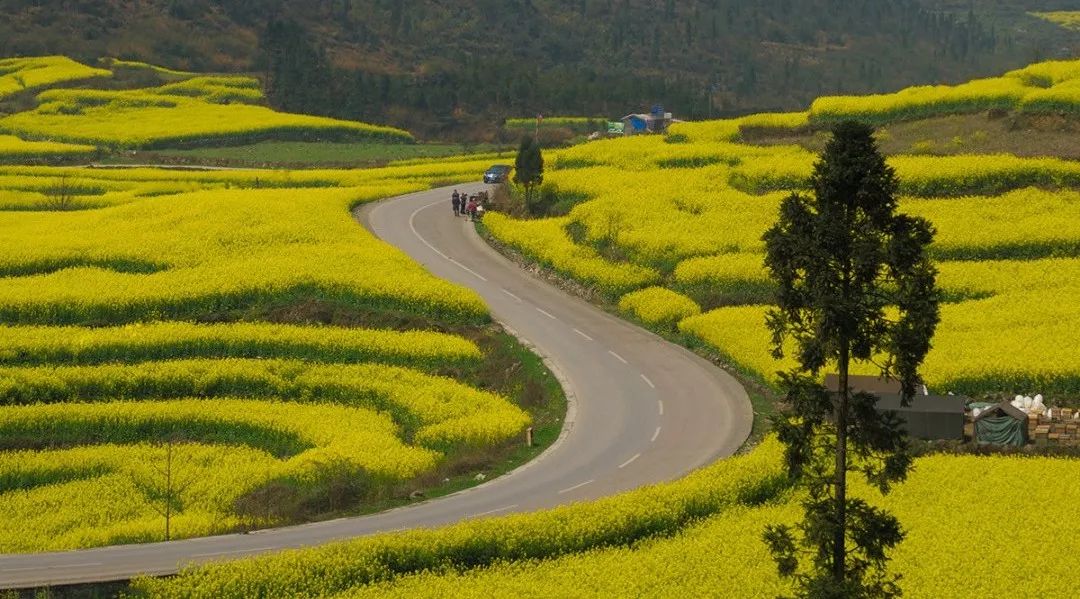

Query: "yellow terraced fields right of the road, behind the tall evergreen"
<box><xmin>487</xmin><ymin>62</ymin><xmax>1080</xmax><ymax>404</ymax></box>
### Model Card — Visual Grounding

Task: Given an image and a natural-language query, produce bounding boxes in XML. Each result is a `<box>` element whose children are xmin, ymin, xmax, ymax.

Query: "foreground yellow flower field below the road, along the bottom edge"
<box><xmin>134</xmin><ymin>439</ymin><xmax>1080</xmax><ymax>598</ymax></box>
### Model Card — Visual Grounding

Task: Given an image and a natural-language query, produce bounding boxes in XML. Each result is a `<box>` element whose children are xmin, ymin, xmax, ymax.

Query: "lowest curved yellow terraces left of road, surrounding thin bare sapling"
<box><xmin>0</xmin><ymin>397</ymin><xmax>445</xmax><ymax>553</ymax></box>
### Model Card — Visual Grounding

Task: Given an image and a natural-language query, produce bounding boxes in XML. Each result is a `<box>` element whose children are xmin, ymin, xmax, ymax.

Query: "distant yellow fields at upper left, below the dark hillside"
<box><xmin>0</xmin><ymin>56</ymin><xmax>415</xmax><ymax>148</ymax></box>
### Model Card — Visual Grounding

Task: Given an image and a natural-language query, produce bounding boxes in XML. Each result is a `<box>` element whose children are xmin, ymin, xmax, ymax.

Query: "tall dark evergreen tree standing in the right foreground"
<box><xmin>764</xmin><ymin>122</ymin><xmax>939</xmax><ymax>598</ymax></box>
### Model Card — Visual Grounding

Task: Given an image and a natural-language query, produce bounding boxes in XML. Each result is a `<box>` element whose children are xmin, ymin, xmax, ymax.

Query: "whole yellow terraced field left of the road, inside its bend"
<box><xmin>0</xmin><ymin>157</ymin><xmax>544</xmax><ymax>553</ymax></box>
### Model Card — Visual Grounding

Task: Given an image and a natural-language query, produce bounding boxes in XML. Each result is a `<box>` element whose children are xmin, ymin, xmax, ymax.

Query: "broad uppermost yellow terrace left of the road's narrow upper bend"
<box><xmin>0</xmin><ymin>182</ymin><xmax>489</xmax><ymax>324</ymax></box>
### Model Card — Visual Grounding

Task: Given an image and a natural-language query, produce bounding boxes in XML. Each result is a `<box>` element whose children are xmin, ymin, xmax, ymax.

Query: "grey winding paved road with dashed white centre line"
<box><xmin>0</xmin><ymin>180</ymin><xmax>753</xmax><ymax>588</ymax></box>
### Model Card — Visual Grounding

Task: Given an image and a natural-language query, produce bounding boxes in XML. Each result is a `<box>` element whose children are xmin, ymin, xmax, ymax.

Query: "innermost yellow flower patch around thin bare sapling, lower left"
<box><xmin>0</xmin><ymin>443</ymin><xmax>270</xmax><ymax>553</ymax></box>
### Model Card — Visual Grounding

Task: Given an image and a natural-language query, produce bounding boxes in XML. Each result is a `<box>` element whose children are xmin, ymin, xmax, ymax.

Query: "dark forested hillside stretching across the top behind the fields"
<box><xmin>0</xmin><ymin>0</ymin><xmax>1080</xmax><ymax>135</ymax></box>
